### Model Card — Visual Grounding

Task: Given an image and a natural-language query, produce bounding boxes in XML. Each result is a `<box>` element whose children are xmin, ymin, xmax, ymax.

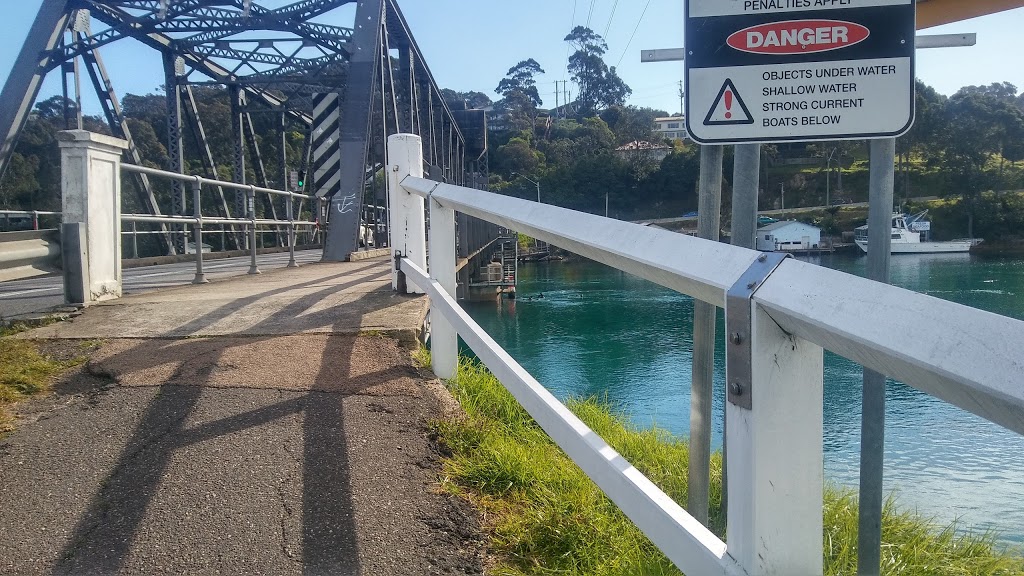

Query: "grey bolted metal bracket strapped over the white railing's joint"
<box><xmin>725</xmin><ymin>252</ymin><xmax>790</xmax><ymax>410</ymax></box>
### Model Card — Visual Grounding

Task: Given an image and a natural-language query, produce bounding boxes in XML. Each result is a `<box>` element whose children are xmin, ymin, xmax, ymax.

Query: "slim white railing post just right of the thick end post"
<box><xmin>430</xmin><ymin>199</ymin><xmax>459</xmax><ymax>379</ymax></box>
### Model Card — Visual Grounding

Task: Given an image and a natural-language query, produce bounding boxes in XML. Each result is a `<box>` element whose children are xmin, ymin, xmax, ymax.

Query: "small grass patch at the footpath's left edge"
<box><xmin>0</xmin><ymin>325</ymin><xmax>85</xmax><ymax>435</ymax></box>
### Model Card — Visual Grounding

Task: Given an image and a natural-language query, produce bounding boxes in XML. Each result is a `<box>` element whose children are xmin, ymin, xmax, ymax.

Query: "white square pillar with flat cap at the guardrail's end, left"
<box><xmin>57</xmin><ymin>130</ymin><xmax>128</xmax><ymax>304</ymax></box>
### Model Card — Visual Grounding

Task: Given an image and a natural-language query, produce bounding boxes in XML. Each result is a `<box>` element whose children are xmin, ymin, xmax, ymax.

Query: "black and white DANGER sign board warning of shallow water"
<box><xmin>685</xmin><ymin>0</ymin><xmax>915</xmax><ymax>145</ymax></box>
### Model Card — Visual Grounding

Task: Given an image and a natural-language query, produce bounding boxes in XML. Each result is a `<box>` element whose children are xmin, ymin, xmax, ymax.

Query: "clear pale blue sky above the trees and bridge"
<box><xmin>0</xmin><ymin>0</ymin><xmax>1024</xmax><ymax>117</ymax></box>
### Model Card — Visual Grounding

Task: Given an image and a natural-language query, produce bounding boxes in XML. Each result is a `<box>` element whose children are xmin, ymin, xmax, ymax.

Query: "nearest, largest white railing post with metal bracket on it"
<box><xmin>726</xmin><ymin>303</ymin><xmax>824</xmax><ymax>576</ymax></box>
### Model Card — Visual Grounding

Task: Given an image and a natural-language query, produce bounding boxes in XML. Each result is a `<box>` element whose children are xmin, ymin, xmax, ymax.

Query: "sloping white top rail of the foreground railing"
<box><xmin>401</xmin><ymin>176</ymin><xmax>1024</xmax><ymax>435</ymax></box>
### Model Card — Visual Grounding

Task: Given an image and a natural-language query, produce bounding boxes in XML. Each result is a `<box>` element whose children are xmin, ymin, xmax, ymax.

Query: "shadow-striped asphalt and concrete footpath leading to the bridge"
<box><xmin>0</xmin><ymin>259</ymin><xmax>483</xmax><ymax>575</ymax></box>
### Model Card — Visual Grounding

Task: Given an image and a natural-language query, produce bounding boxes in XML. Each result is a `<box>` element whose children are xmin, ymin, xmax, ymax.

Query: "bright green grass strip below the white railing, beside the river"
<box><xmin>432</xmin><ymin>355</ymin><xmax>1024</xmax><ymax>576</ymax></box>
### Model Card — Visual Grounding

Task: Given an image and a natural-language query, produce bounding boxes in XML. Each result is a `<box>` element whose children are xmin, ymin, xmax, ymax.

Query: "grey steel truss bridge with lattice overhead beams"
<box><xmin>0</xmin><ymin>0</ymin><xmax>488</xmax><ymax>260</ymax></box>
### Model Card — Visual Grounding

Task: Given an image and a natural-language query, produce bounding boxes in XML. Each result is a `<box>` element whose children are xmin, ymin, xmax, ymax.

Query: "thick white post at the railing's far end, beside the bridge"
<box><xmin>387</xmin><ymin>134</ymin><xmax>428</xmax><ymax>294</ymax></box>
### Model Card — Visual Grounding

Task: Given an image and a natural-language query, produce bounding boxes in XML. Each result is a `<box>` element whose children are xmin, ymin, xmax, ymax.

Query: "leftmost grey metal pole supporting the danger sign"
<box><xmin>686</xmin><ymin>141</ymin><xmax>725</xmax><ymax>526</ymax></box>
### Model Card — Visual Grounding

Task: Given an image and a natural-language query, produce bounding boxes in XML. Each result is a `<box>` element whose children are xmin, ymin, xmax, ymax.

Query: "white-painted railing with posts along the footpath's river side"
<box><xmin>388</xmin><ymin>134</ymin><xmax>1024</xmax><ymax>575</ymax></box>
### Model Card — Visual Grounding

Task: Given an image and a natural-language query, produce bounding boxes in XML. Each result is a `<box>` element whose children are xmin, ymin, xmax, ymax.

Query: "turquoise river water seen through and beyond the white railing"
<box><xmin>464</xmin><ymin>250</ymin><xmax>1024</xmax><ymax>545</ymax></box>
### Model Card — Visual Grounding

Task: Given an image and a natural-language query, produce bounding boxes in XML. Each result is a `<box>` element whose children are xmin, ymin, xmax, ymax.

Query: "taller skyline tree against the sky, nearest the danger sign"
<box><xmin>565</xmin><ymin>26</ymin><xmax>633</xmax><ymax>118</ymax></box>
